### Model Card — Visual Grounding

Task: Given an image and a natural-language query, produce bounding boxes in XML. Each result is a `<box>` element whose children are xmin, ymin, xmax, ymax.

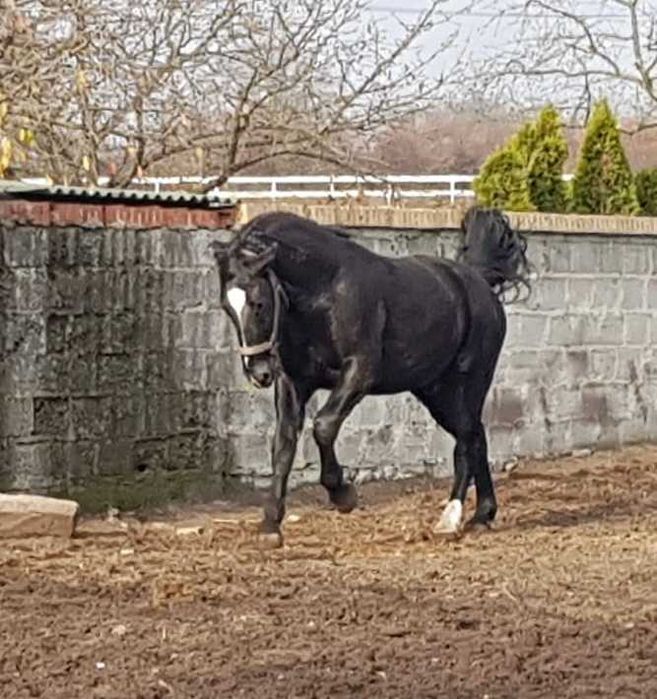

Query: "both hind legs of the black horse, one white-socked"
<box><xmin>417</xmin><ymin>374</ymin><xmax>497</xmax><ymax>533</ymax></box>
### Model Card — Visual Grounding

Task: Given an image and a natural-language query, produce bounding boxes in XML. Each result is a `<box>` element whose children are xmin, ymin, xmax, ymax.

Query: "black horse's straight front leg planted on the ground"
<box><xmin>261</xmin><ymin>375</ymin><xmax>308</xmax><ymax>546</ymax></box>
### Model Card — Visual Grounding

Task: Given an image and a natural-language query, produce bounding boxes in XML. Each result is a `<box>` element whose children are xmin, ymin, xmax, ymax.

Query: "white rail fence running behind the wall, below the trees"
<box><xmin>18</xmin><ymin>175</ymin><xmax>573</xmax><ymax>204</ymax></box>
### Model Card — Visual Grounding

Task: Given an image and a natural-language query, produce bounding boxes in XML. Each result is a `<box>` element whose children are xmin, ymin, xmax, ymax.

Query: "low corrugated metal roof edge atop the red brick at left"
<box><xmin>0</xmin><ymin>180</ymin><xmax>235</xmax><ymax>209</ymax></box>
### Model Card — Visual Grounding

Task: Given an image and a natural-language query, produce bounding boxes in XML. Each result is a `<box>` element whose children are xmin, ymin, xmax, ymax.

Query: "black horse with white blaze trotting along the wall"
<box><xmin>212</xmin><ymin>208</ymin><xmax>528</xmax><ymax>544</ymax></box>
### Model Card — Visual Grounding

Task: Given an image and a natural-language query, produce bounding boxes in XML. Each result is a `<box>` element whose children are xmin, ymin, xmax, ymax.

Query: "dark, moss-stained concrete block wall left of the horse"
<box><xmin>0</xmin><ymin>223</ymin><xmax>235</xmax><ymax>509</ymax></box>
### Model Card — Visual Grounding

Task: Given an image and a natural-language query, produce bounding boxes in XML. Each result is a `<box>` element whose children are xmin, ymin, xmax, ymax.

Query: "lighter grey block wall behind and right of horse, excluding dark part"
<box><xmin>234</xmin><ymin>229</ymin><xmax>657</xmax><ymax>485</ymax></box>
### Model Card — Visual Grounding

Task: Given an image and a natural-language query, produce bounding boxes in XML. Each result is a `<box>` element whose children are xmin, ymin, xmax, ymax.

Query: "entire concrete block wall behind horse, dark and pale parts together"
<box><xmin>0</xmin><ymin>208</ymin><xmax>657</xmax><ymax>508</ymax></box>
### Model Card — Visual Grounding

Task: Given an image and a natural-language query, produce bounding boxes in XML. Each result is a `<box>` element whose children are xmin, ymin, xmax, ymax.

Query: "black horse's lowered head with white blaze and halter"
<box><xmin>211</xmin><ymin>239</ymin><xmax>286</xmax><ymax>388</ymax></box>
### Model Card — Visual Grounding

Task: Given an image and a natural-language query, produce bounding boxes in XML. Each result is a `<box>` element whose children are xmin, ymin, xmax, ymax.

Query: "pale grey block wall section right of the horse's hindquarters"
<box><xmin>486</xmin><ymin>234</ymin><xmax>657</xmax><ymax>461</ymax></box>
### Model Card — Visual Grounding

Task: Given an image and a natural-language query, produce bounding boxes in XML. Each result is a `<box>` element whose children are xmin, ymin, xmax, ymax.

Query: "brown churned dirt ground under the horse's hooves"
<box><xmin>0</xmin><ymin>447</ymin><xmax>657</xmax><ymax>699</ymax></box>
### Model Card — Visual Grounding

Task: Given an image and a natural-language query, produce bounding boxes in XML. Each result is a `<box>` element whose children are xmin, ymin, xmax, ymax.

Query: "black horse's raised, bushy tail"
<box><xmin>459</xmin><ymin>206</ymin><xmax>531</xmax><ymax>295</ymax></box>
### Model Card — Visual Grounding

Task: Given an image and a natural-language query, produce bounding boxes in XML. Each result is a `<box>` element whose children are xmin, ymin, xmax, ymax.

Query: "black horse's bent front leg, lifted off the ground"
<box><xmin>313</xmin><ymin>358</ymin><xmax>372</xmax><ymax>512</ymax></box>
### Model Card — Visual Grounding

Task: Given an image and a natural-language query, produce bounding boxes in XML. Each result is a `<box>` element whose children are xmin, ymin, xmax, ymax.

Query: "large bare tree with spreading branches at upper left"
<box><xmin>0</xmin><ymin>0</ymin><xmax>464</xmax><ymax>187</ymax></box>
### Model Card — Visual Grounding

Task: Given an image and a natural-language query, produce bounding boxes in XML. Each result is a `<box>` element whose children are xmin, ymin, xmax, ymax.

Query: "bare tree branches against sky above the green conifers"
<box><xmin>474</xmin><ymin>0</ymin><xmax>657</xmax><ymax>131</ymax></box>
